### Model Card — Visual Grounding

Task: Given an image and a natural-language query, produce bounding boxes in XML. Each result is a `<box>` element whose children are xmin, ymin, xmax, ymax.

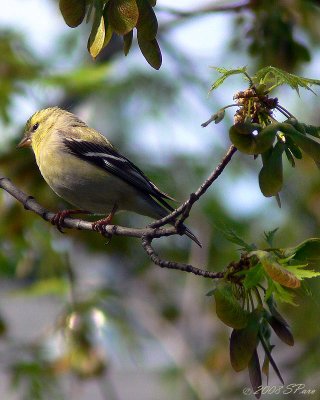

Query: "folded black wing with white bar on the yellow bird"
<box><xmin>63</xmin><ymin>138</ymin><xmax>174</xmax><ymax>211</ymax></box>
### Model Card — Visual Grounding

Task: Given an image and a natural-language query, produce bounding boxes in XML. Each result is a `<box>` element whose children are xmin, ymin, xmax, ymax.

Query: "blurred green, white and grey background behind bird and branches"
<box><xmin>0</xmin><ymin>0</ymin><xmax>320</xmax><ymax>400</ymax></box>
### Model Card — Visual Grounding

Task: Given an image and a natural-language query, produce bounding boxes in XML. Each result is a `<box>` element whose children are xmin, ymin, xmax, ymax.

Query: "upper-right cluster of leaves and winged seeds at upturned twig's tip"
<box><xmin>203</xmin><ymin>66</ymin><xmax>320</xmax><ymax>202</ymax></box>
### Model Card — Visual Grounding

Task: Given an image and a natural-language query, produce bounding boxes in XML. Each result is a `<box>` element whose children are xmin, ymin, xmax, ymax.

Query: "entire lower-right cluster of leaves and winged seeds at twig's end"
<box><xmin>208</xmin><ymin>229</ymin><xmax>320</xmax><ymax>398</ymax></box>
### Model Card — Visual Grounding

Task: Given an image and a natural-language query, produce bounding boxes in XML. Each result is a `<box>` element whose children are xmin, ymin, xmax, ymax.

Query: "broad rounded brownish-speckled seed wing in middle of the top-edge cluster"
<box><xmin>107</xmin><ymin>0</ymin><xmax>139</xmax><ymax>35</ymax></box>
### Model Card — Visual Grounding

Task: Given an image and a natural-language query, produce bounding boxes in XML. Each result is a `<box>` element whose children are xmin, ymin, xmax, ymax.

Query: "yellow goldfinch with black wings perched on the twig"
<box><xmin>18</xmin><ymin>107</ymin><xmax>201</xmax><ymax>246</ymax></box>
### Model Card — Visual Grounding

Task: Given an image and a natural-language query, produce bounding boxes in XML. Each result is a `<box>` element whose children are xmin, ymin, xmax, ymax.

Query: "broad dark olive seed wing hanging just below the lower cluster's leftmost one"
<box><xmin>230</xmin><ymin>312</ymin><xmax>260</xmax><ymax>372</ymax></box>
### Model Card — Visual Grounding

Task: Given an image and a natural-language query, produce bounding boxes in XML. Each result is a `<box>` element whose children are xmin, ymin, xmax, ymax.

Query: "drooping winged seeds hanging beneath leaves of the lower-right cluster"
<box><xmin>213</xmin><ymin>284</ymin><xmax>294</xmax><ymax>398</ymax></box>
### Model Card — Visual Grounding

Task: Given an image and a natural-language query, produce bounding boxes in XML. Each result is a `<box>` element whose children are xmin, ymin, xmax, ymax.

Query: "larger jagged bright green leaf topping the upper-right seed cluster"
<box><xmin>252</xmin><ymin>66</ymin><xmax>320</xmax><ymax>94</ymax></box>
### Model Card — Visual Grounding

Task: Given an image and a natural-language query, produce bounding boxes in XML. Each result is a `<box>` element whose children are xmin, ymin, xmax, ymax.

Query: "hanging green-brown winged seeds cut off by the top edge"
<box><xmin>59</xmin><ymin>0</ymin><xmax>162</xmax><ymax>69</ymax></box>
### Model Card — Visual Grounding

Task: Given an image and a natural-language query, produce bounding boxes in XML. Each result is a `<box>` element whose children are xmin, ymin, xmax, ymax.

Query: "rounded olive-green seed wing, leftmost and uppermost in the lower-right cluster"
<box><xmin>213</xmin><ymin>285</ymin><xmax>249</xmax><ymax>329</ymax></box>
